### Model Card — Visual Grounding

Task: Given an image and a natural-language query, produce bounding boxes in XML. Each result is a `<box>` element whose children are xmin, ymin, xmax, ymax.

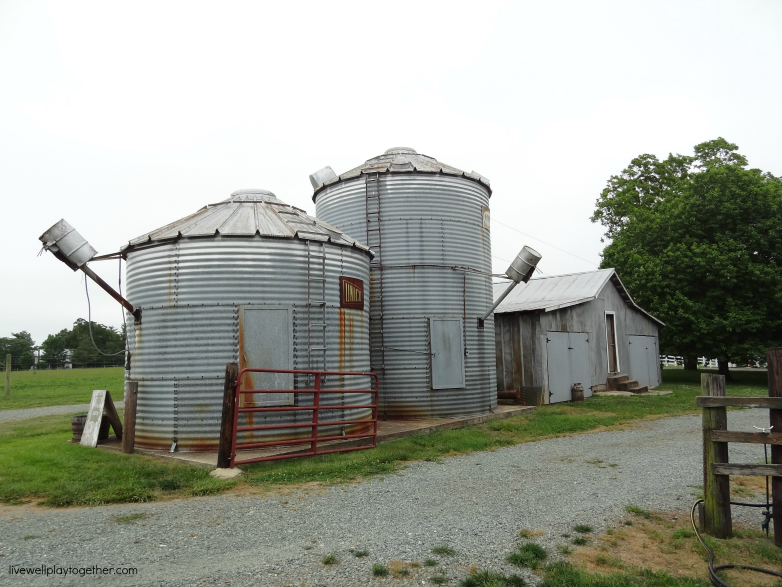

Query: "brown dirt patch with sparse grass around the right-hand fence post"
<box><xmin>567</xmin><ymin>511</ymin><xmax>782</xmax><ymax>587</ymax></box>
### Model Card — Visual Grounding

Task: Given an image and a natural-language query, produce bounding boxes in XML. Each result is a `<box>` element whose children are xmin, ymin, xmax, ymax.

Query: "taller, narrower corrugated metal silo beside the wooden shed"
<box><xmin>310</xmin><ymin>147</ymin><xmax>497</xmax><ymax>419</ymax></box>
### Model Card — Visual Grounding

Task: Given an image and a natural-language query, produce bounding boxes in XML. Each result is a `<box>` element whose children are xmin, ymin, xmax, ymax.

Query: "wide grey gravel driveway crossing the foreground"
<box><xmin>0</xmin><ymin>410</ymin><xmax>768</xmax><ymax>587</ymax></box>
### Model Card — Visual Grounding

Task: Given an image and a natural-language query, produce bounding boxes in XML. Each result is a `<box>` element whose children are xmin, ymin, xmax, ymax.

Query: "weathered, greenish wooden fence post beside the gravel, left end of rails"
<box><xmin>701</xmin><ymin>373</ymin><xmax>733</xmax><ymax>538</ymax></box>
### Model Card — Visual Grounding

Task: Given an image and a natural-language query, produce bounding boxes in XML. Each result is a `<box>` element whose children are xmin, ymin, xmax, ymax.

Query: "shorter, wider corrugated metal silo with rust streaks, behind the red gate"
<box><xmin>122</xmin><ymin>190</ymin><xmax>372</xmax><ymax>450</ymax></box>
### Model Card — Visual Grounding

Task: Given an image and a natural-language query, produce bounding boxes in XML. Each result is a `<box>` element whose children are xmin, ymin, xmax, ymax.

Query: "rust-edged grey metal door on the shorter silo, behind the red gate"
<box><xmin>239</xmin><ymin>306</ymin><xmax>293</xmax><ymax>407</ymax></box>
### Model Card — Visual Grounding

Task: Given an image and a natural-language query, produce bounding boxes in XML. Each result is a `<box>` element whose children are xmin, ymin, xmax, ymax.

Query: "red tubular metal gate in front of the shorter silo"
<box><xmin>231</xmin><ymin>369</ymin><xmax>379</xmax><ymax>468</ymax></box>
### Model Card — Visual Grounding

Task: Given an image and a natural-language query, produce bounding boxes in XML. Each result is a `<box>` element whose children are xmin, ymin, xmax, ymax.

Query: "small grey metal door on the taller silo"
<box><xmin>429</xmin><ymin>318</ymin><xmax>464</xmax><ymax>389</ymax></box>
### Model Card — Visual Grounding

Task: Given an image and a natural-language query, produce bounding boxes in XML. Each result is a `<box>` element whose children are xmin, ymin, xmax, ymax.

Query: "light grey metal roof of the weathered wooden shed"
<box><xmin>494</xmin><ymin>269</ymin><xmax>665</xmax><ymax>326</ymax></box>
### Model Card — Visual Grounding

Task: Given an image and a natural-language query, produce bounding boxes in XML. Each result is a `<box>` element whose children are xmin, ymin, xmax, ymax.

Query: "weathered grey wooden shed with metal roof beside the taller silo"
<box><xmin>494</xmin><ymin>269</ymin><xmax>664</xmax><ymax>404</ymax></box>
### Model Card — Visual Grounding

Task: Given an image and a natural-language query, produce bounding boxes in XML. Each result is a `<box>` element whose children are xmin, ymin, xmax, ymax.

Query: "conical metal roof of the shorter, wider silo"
<box><xmin>121</xmin><ymin>189</ymin><xmax>369</xmax><ymax>253</ymax></box>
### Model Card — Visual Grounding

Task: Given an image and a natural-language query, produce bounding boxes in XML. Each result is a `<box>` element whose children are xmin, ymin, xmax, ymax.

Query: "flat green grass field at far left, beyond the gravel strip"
<box><xmin>0</xmin><ymin>367</ymin><xmax>125</xmax><ymax>410</ymax></box>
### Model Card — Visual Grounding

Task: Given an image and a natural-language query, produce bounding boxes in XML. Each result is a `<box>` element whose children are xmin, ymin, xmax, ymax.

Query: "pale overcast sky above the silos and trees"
<box><xmin>0</xmin><ymin>0</ymin><xmax>782</xmax><ymax>343</ymax></box>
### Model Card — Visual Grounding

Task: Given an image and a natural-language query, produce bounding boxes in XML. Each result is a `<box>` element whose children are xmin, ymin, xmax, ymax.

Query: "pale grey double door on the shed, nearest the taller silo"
<box><xmin>546</xmin><ymin>332</ymin><xmax>592</xmax><ymax>404</ymax></box>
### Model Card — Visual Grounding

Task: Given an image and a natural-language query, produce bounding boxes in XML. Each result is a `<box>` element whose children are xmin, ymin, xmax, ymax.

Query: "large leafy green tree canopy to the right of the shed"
<box><xmin>592</xmin><ymin>138</ymin><xmax>782</xmax><ymax>372</ymax></box>
